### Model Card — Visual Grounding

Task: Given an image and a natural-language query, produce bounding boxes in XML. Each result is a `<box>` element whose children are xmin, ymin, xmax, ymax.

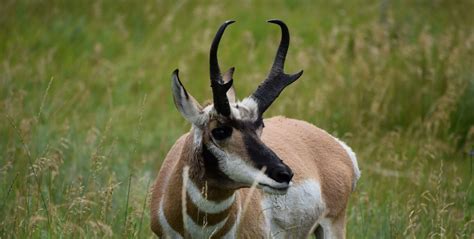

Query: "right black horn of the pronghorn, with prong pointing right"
<box><xmin>252</xmin><ymin>19</ymin><xmax>303</xmax><ymax>115</ymax></box>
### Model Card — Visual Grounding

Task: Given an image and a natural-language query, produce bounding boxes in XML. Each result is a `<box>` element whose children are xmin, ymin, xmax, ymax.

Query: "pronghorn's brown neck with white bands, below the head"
<box><xmin>159</xmin><ymin>134</ymin><xmax>240</xmax><ymax>238</ymax></box>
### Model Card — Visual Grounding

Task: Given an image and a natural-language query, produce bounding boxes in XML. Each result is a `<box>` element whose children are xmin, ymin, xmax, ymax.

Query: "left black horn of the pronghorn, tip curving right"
<box><xmin>209</xmin><ymin>20</ymin><xmax>235</xmax><ymax>116</ymax></box>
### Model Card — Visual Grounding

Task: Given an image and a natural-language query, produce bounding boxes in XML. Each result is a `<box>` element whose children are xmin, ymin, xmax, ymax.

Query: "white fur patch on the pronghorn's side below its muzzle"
<box><xmin>261</xmin><ymin>180</ymin><xmax>326</xmax><ymax>238</ymax></box>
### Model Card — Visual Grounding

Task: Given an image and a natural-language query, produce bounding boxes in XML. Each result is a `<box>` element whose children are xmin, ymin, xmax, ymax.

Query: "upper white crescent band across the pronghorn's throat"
<box><xmin>186</xmin><ymin>177</ymin><xmax>235</xmax><ymax>213</ymax></box>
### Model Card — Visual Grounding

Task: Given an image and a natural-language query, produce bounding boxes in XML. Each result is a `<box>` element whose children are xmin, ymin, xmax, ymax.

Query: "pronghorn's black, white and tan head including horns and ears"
<box><xmin>172</xmin><ymin>20</ymin><xmax>303</xmax><ymax>193</ymax></box>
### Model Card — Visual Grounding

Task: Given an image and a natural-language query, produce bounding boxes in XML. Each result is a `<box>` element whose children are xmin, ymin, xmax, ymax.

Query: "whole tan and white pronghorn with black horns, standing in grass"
<box><xmin>151</xmin><ymin>20</ymin><xmax>360</xmax><ymax>238</ymax></box>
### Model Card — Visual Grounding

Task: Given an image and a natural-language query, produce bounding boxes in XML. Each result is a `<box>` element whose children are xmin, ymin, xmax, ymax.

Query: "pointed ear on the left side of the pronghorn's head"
<box><xmin>171</xmin><ymin>69</ymin><xmax>204</xmax><ymax>126</ymax></box>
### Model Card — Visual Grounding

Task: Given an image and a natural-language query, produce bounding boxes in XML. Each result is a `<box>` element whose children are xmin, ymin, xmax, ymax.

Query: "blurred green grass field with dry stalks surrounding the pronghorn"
<box><xmin>0</xmin><ymin>0</ymin><xmax>474</xmax><ymax>238</ymax></box>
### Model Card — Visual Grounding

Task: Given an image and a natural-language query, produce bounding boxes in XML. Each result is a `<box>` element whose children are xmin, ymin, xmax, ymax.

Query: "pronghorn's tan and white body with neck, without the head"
<box><xmin>151</xmin><ymin>117</ymin><xmax>360</xmax><ymax>238</ymax></box>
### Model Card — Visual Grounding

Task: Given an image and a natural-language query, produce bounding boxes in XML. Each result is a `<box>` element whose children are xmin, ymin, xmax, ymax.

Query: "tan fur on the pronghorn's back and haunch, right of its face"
<box><xmin>262</xmin><ymin>117</ymin><xmax>355</xmax><ymax>217</ymax></box>
